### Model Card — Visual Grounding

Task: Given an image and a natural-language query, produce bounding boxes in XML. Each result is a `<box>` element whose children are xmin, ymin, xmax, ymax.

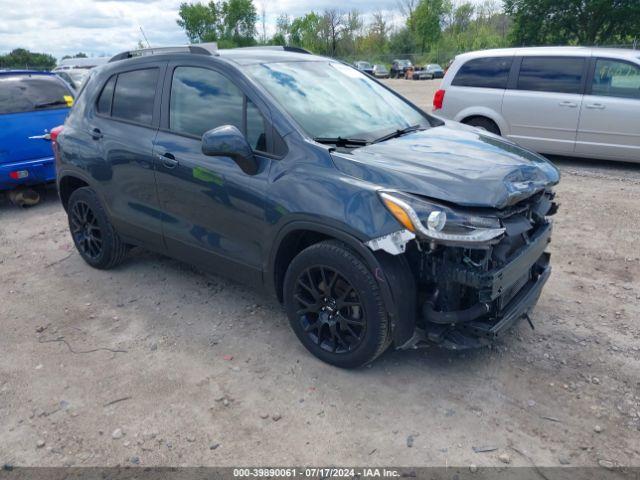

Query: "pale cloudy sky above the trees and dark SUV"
<box><xmin>0</xmin><ymin>0</ymin><xmax>397</xmax><ymax>59</ymax></box>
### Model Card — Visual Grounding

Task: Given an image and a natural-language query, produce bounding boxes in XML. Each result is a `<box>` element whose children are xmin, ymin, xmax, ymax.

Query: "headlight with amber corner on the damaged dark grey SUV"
<box><xmin>379</xmin><ymin>191</ymin><xmax>505</xmax><ymax>245</ymax></box>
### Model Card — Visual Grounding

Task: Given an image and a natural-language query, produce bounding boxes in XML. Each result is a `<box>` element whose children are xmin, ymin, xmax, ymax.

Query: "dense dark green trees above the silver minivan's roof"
<box><xmin>505</xmin><ymin>0</ymin><xmax>640</xmax><ymax>45</ymax></box>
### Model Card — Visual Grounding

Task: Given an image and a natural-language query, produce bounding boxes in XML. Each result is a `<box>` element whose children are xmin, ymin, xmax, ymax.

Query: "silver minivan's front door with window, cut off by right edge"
<box><xmin>576</xmin><ymin>58</ymin><xmax>640</xmax><ymax>162</ymax></box>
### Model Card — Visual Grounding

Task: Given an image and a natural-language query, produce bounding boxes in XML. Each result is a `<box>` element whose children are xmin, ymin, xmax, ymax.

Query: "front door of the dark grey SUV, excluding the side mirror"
<box><xmin>154</xmin><ymin>65</ymin><xmax>271</xmax><ymax>283</ymax></box>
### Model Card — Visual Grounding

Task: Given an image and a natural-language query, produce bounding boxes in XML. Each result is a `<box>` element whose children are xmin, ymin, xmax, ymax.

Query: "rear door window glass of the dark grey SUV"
<box><xmin>111</xmin><ymin>68</ymin><xmax>158</xmax><ymax>125</ymax></box>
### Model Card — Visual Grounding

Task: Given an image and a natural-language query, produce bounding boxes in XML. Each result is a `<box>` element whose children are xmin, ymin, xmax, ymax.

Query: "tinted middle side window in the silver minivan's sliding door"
<box><xmin>518</xmin><ymin>57</ymin><xmax>585</xmax><ymax>93</ymax></box>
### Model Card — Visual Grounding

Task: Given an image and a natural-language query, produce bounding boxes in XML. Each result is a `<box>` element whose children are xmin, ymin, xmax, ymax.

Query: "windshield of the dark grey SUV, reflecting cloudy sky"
<box><xmin>247</xmin><ymin>61</ymin><xmax>429</xmax><ymax>141</ymax></box>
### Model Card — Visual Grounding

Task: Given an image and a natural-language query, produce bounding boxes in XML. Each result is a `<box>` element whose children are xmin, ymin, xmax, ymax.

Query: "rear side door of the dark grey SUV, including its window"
<box><xmin>85</xmin><ymin>62</ymin><xmax>166</xmax><ymax>249</ymax></box>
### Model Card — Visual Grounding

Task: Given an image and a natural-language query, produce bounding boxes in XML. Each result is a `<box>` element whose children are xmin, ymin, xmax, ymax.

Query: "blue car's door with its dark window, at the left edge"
<box><xmin>0</xmin><ymin>73</ymin><xmax>73</xmax><ymax>163</ymax></box>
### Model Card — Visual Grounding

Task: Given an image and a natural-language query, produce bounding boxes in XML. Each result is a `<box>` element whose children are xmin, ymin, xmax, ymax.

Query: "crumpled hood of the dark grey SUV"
<box><xmin>332</xmin><ymin>122</ymin><xmax>560</xmax><ymax>208</ymax></box>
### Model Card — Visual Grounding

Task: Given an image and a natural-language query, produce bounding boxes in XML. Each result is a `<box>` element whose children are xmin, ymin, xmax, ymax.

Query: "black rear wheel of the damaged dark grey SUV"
<box><xmin>67</xmin><ymin>187</ymin><xmax>127</xmax><ymax>270</ymax></box>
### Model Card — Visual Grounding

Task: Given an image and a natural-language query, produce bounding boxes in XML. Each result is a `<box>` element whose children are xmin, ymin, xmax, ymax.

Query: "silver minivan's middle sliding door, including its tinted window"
<box><xmin>502</xmin><ymin>56</ymin><xmax>588</xmax><ymax>155</ymax></box>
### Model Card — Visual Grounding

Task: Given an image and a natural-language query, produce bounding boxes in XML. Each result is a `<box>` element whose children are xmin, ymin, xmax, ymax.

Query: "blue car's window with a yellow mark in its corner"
<box><xmin>0</xmin><ymin>75</ymin><xmax>73</xmax><ymax>114</ymax></box>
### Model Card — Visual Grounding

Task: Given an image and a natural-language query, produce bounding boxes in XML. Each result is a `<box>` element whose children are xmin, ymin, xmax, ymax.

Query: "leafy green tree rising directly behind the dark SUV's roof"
<box><xmin>177</xmin><ymin>0</ymin><xmax>258</xmax><ymax>48</ymax></box>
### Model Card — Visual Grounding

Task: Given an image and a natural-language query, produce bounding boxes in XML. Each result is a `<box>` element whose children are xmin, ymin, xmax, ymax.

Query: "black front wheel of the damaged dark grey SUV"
<box><xmin>283</xmin><ymin>240</ymin><xmax>390</xmax><ymax>368</ymax></box>
